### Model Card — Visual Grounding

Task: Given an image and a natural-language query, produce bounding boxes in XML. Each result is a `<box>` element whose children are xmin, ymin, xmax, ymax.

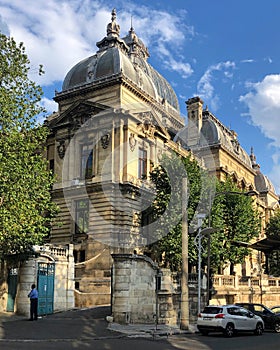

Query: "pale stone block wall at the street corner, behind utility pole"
<box><xmin>112</xmin><ymin>254</ymin><xmax>209</xmax><ymax>326</ymax></box>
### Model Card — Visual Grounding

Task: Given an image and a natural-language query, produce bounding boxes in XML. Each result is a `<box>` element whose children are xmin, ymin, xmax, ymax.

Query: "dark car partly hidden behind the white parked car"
<box><xmin>236</xmin><ymin>303</ymin><xmax>280</xmax><ymax>333</ymax></box>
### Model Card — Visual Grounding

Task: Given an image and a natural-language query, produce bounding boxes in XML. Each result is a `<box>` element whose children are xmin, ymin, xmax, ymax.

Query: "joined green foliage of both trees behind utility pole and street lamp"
<box><xmin>150</xmin><ymin>155</ymin><xmax>260</xmax><ymax>272</ymax></box>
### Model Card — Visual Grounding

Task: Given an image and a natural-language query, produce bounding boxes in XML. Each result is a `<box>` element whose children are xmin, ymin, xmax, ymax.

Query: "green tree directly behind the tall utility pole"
<box><xmin>149</xmin><ymin>154</ymin><xmax>210</xmax><ymax>271</ymax></box>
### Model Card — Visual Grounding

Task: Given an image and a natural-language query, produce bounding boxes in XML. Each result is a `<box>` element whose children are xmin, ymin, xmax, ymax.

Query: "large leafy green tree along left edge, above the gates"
<box><xmin>0</xmin><ymin>34</ymin><xmax>57</xmax><ymax>260</ymax></box>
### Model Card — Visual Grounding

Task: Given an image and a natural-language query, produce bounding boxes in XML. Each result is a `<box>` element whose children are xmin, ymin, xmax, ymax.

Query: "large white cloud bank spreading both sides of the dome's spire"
<box><xmin>0</xmin><ymin>0</ymin><xmax>193</xmax><ymax>86</ymax></box>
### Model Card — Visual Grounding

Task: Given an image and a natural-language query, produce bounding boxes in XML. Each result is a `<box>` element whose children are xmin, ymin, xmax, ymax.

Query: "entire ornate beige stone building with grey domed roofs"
<box><xmin>44</xmin><ymin>10</ymin><xmax>278</xmax><ymax>306</ymax></box>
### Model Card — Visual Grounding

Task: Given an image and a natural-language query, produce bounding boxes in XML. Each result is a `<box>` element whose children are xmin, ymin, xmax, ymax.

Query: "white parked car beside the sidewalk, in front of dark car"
<box><xmin>197</xmin><ymin>305</ymin><xmax>264</xmax><ymax>337</ymax></box>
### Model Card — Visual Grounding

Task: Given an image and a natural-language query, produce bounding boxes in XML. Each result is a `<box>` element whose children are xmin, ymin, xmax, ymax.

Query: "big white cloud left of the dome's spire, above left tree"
<box><xmin>0</xmin><ymin>0</ymin><xmax>110</xmax><ymax>85</ymax></box>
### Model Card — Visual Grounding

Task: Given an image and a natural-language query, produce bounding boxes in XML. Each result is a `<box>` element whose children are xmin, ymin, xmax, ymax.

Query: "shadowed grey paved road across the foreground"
<box><xmin>0</xmin><ymin>307</ymin><xmax>280</xmax><ymax>350</ymax></box>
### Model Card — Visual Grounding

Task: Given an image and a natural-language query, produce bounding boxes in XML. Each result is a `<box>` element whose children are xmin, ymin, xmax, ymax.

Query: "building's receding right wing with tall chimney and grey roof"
<box><xmin>175</xmin><ymin>97</ymin><xmax>279</xmax><ymax>275</ymax></box>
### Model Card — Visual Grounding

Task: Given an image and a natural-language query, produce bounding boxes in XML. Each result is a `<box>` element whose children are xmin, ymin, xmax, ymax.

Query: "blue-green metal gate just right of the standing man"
<box><xmin>37</xmin><ymin>263</ymin><xmax>55</xmax><ymax>315</ymax></box>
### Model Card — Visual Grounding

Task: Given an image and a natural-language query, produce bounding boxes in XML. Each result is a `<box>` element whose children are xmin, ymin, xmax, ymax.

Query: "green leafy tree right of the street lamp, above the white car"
<box><xmin>208</xmin><ymin>178</ymin><xmax>260</xmax><ymax>273</ymax></box>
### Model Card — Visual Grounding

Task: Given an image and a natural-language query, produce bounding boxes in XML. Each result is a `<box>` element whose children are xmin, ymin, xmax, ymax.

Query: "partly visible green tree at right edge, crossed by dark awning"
<box><xmin>265</xmin><ymin>209</ymin><xmax>280</xmax><ymax>276</ymax></box>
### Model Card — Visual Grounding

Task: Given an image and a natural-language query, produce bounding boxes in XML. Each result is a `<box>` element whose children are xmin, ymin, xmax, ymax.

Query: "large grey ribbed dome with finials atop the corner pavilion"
<box><xmin>62</xmin><ymin>10</ymin><xmax>179</xmax><ymax>113</ymax></box>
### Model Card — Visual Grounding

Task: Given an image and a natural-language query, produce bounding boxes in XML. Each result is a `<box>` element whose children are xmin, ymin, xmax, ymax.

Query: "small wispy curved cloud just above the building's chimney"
<box><xmin>197</xmin><ymin>61</ymin><xmax>235</xmax><ymax>112</ymax></box>
